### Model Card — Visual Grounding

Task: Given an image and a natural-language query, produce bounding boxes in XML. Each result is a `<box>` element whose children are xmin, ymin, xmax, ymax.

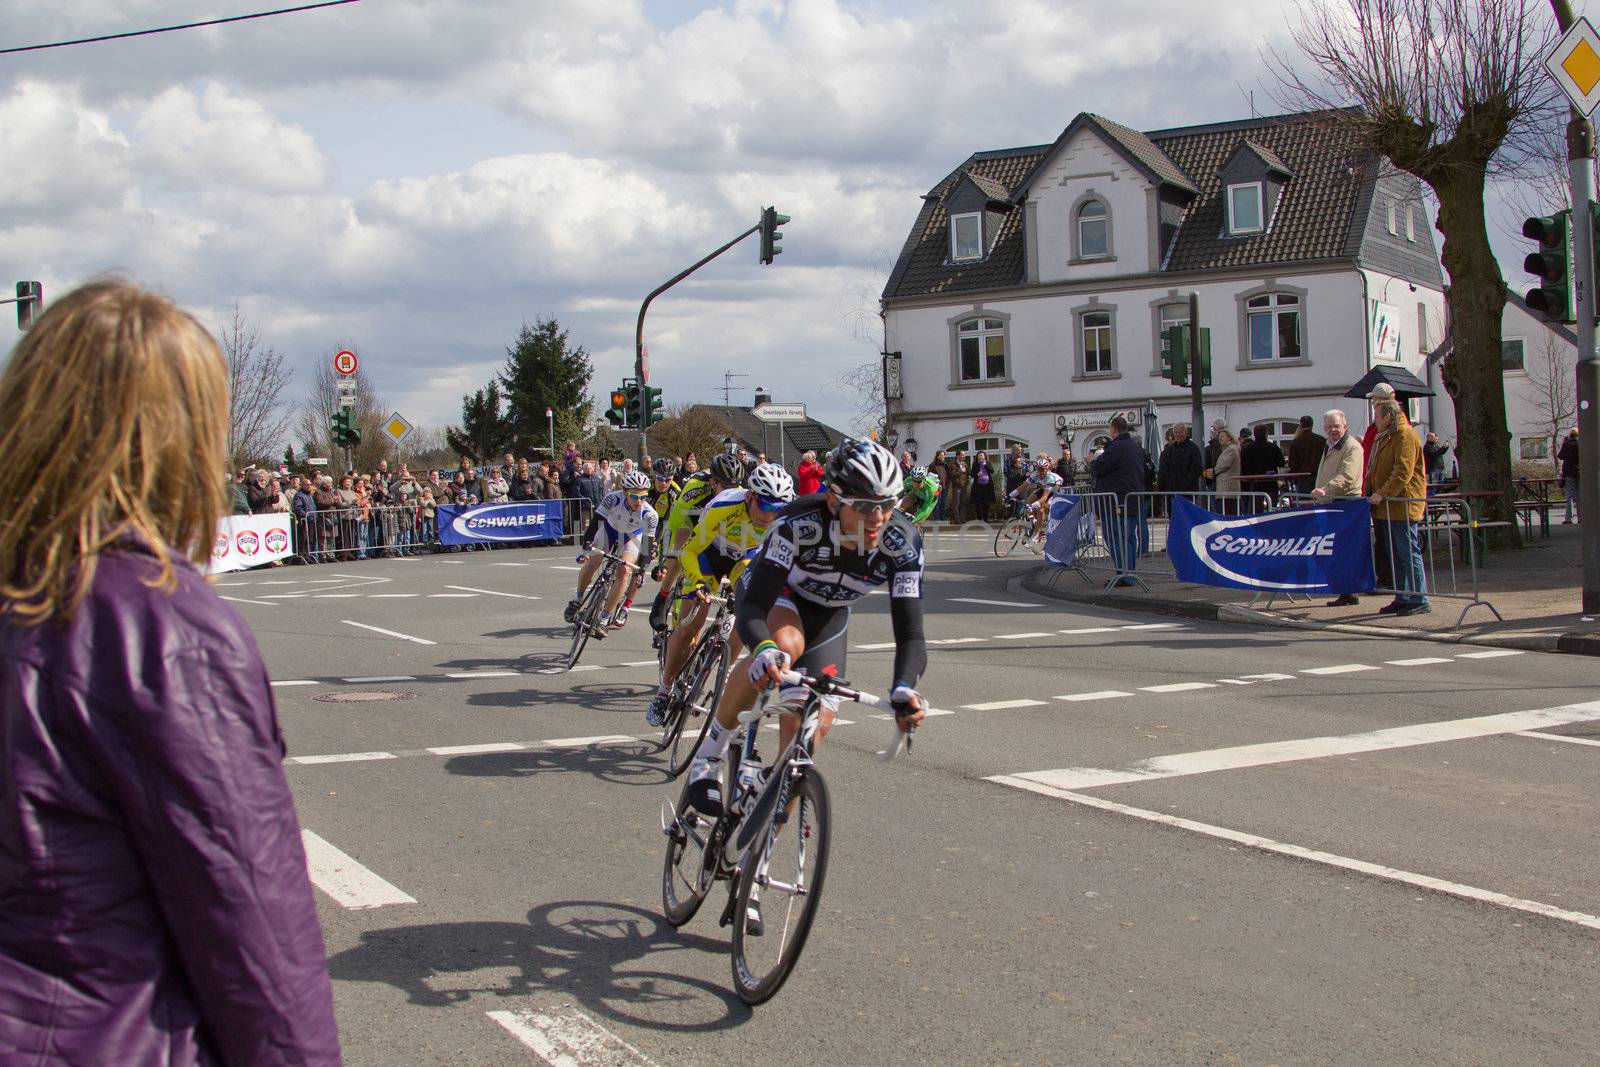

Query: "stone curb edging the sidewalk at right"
<box><xmin>1018</xmin><ymin>568</ymin><xmax>1580</xmax><ymax>656</ymax></box>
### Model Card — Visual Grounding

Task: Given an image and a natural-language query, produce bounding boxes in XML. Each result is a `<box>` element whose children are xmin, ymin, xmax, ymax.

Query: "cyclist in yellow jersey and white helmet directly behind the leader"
<box><xmin>645</xmin><ymin>464</ymin><xmax>795</xmax><ymax>726</ymax></box>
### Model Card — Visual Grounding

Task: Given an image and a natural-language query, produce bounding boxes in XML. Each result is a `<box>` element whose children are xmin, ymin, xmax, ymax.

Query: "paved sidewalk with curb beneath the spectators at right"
<box><xmin>1022</xmin><ymin>525</ymin><xmax>1600</xmax><ymax>656</ymax></box>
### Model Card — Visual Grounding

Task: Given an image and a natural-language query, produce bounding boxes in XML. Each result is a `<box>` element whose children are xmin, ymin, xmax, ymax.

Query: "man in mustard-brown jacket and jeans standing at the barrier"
<box><xmin>1366</xmin><ymin>398</ymin><xmax>1432</xmax><ymax>616</ymax></box>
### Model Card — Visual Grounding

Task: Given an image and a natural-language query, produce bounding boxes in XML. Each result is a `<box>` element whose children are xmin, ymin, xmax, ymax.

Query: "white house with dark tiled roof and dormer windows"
<box><xmin>882</xmin><ymin>112</ymin><xmax>1453</xmax><ymax>459</ymax></box>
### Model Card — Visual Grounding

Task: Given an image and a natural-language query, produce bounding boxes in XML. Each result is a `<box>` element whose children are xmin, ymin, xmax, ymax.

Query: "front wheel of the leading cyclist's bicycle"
<box><xmin>733</xmin><ymin>766</ymin><xmax>829</xmax><ymax>1005</ymax></box>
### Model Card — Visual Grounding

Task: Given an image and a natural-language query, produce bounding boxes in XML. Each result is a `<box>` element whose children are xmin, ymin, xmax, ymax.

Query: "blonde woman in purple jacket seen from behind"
<box><xmin>0</xmin><ymin>282</ymin><xmax>339</xmax><ymax>1065</ymax></box>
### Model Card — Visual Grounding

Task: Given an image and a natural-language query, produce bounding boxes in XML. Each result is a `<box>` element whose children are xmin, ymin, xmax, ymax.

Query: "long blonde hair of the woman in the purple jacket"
<box><xmin>0</xmin><ymin>280</ymin><xmax>227</xmax><ymax>624</ymax></box>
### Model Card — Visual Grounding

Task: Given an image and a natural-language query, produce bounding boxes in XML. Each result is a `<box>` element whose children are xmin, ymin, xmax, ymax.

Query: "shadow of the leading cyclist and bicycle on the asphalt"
<box><xmin>328</xmin><ymin>901</ymin><xmax>750</xmax><ymax>1032</ymax></box>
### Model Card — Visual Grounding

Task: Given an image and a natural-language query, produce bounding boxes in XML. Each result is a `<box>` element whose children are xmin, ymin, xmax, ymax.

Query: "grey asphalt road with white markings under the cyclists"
<box><xmin>228</xmin><ymin>536</ymin><xmax>1600</xmax><ymax>1067</ymax></box>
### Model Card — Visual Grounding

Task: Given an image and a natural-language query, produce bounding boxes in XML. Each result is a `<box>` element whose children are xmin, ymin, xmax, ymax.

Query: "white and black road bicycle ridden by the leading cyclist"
<box><xmin>661</xmin><ymin>672</ymin><xmax>912</xmax><ymax>1005</ymax></box>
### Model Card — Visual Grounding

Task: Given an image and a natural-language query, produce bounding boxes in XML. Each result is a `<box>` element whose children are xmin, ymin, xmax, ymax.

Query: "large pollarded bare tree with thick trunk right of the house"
<box><xmin>1270</xmin><ymin>0</ymin><xmax>1557</xmax><ymax>544</ymax></box>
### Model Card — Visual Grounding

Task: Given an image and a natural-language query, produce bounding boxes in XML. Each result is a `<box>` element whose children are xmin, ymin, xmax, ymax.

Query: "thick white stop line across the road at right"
<box><xmin>1013</xmin><ymin>701</ymin><xmax>1600</xmax><ymax>789</ymax></box>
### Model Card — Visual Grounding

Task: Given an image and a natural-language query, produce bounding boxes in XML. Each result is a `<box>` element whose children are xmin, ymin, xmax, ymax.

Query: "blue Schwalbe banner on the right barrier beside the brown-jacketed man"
<box><xmin>1166</xmin><ymin>498</ymin><xmax>1376</xmax><ymax>593</ymax></box>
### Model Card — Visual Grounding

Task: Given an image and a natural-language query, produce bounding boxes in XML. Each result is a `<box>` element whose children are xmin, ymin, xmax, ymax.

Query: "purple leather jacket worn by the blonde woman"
<box><xmin>0</xmin><ymin>544</ymin><xmax>339</xmax><ymax>1065</ymax></box>
